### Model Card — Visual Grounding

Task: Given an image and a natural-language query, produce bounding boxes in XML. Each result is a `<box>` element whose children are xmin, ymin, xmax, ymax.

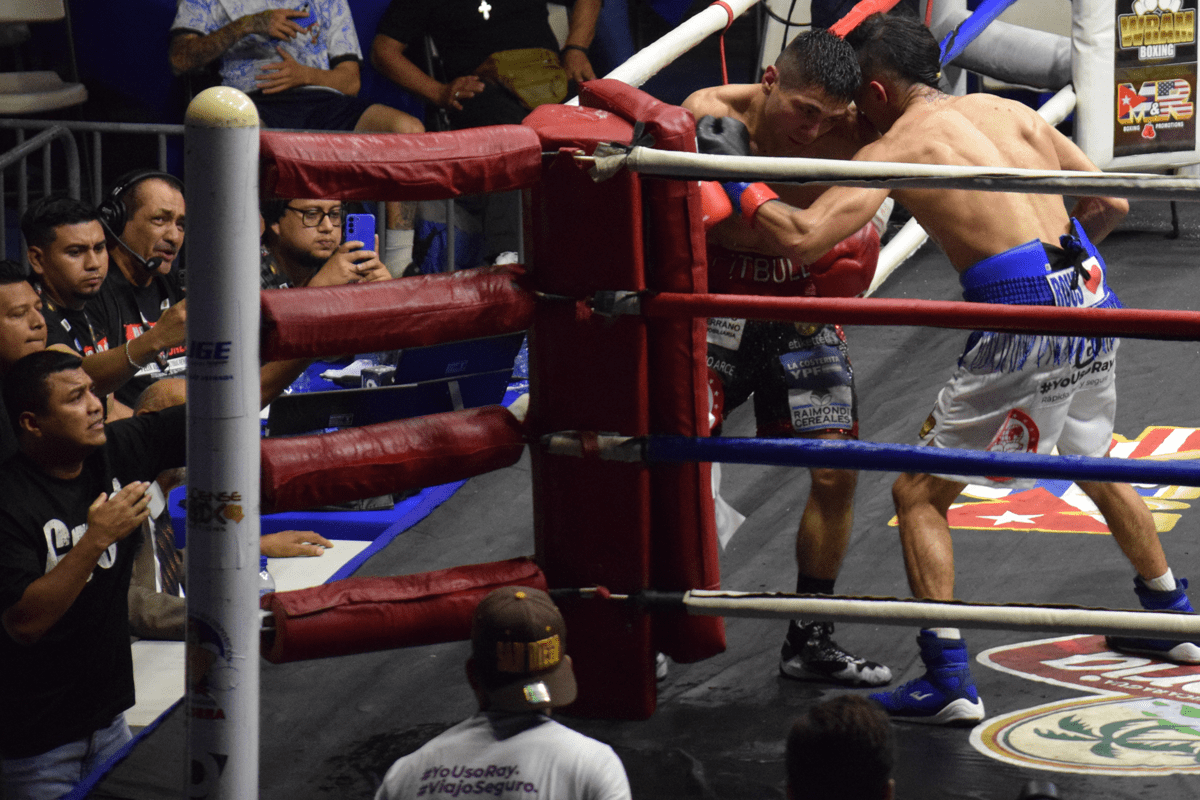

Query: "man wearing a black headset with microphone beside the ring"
<box><xmin>86</xmin><ymin>170</ymin><xmax>186</xmax><ymax>408</ymax></box>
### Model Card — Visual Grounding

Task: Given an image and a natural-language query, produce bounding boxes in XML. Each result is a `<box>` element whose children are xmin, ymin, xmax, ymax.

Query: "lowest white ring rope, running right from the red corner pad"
<box><xmin>683</xmin><ymin>589</ymin><xmax>1200</xmax><ymax>640</ymax></box>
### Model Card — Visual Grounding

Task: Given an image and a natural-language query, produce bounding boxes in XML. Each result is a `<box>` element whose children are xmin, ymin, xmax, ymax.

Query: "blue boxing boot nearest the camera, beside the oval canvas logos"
<box><xmin>871</xmin><ymin>630</ymin><xmax>983</xmax><ymax>726</ymax></box>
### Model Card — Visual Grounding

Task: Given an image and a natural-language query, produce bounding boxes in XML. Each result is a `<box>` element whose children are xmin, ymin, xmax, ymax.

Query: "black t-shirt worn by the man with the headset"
<box><xmin>85</xmin><ymin>269</ymin><xmax>187</xmax><ymax>408</ymax></box>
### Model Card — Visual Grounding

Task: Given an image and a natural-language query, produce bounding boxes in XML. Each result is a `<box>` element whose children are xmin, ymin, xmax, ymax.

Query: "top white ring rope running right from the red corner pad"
<box><xmin>592</xmin><ymin>146</ymin><xmax>1200</xmax><ymax>201</ymax></box>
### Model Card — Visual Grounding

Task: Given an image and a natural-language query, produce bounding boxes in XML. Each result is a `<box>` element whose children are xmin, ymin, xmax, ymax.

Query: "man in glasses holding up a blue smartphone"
<box><xmin>262</xmin><ymin>199</ymin><xmax>391</xmax><ymax>288</ymax></box>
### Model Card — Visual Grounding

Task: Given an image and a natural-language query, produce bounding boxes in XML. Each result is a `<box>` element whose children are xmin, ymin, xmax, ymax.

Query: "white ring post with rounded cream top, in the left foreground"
<box><xmin>184</xmin><ymin>86</ymin><xmax>260</xmax><ymax>798</ymax></box>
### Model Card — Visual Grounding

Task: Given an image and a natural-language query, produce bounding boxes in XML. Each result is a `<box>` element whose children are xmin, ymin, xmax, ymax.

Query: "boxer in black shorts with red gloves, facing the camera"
<box><xmin>684</xmin><ymin>30</ymin><xmax>892</xmax><ymax>686</ymax></box>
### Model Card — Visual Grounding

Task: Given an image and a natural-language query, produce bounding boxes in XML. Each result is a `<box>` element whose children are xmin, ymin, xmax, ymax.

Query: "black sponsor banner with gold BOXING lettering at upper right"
<box><xmin>1112</xmin><ymin>0</ymin><xmax>1196</xmax><ymax>156</ymax></box>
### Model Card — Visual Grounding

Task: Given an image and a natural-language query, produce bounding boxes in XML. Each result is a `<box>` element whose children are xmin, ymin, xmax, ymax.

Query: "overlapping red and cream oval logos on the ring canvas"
<box><xmin>971</xmin><ymin>636</ymin><xmax>1200</xmax><ymax>776</ymax></box>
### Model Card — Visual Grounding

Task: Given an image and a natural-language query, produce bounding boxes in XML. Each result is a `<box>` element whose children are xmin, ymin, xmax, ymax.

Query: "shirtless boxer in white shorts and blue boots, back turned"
<box><xmin>721</xmin><ymin>13</ymin><xmax>1200</xmax><ymax>724</ymax></box>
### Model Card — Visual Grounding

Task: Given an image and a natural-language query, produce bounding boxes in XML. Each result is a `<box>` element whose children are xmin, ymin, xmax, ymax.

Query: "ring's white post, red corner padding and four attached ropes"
<box><xmin>82</xmin><ymin>1</ymin><xmax>1200</xmax><ymax>796</ymax></box>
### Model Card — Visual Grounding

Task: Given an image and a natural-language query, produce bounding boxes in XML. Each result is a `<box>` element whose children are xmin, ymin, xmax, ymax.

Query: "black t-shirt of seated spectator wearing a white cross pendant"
<box><xmin>377</xmin><ymin>0</ymin><xmax>558</xmax><ymax>80</ymax></box>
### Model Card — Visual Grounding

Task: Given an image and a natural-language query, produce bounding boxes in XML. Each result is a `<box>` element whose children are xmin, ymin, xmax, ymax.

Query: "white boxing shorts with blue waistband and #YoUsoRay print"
<box><xmin>920</xmin><ymin>223</ymin><xmax>1121</xmax><ymax>488</ymax></box>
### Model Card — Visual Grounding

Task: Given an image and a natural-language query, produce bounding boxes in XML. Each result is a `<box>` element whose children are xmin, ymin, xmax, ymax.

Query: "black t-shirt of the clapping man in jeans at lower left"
<box><xmin>0</xmin><ymin>405</ymin><xmax>186</xmax><ymax>758</ymax></box>
